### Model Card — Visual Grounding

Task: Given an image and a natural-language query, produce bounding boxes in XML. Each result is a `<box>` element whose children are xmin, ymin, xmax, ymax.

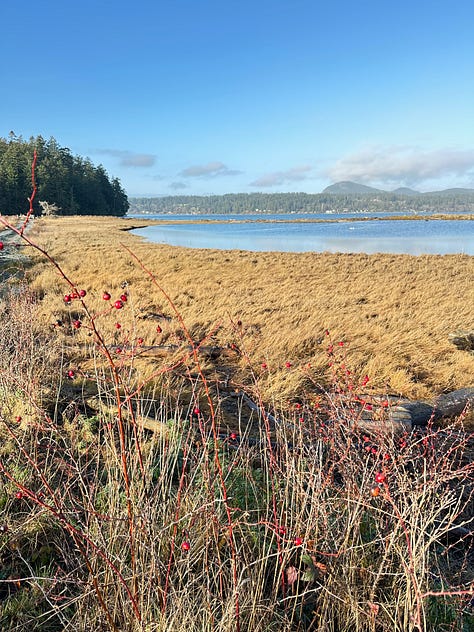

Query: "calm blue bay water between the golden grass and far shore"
<box><xmin>129</xmin><ymin>213</ymin><xmax>474</xmax><ymax>255</ymax></box>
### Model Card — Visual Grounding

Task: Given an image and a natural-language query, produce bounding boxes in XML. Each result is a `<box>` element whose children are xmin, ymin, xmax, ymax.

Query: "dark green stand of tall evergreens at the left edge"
<box><xmin>0</xmin><ymin>133</ymin><xmax>129</xmax><ymax>216</ymax></box>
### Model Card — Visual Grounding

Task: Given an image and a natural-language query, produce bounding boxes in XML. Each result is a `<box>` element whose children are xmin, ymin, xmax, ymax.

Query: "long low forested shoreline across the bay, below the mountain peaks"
<box><xmin>130</xmin><ymin>189</ymin><xmax>474</xmax><ymax>214</ymax></box>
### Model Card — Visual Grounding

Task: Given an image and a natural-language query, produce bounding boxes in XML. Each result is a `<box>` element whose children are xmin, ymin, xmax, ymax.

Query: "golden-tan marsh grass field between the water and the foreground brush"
<box><xmin>25</xmin><ymin>217</ymin><xmax>474</xmax><ymax>399</ymax></box>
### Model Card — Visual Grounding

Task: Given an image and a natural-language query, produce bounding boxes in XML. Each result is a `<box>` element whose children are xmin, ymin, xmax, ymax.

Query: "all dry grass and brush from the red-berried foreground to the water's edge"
<box><xmin>0</xmin><ymin>218</ymin><xmax>474</xmax><ymax>632</ymax></box>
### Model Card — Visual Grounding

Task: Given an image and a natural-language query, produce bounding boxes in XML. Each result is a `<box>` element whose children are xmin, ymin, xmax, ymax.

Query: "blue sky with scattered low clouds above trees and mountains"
<box><xmin>0</xmin><ymin>0</ymin><xmax>474</xmax><ymax>195</ymax></box>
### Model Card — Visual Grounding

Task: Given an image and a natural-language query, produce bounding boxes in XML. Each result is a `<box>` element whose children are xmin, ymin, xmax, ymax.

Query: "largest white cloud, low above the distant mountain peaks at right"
<box><xmin>324</xmin><ymin>146</ymin><xmax>474</xmax><ymax>186</ymax></box>
